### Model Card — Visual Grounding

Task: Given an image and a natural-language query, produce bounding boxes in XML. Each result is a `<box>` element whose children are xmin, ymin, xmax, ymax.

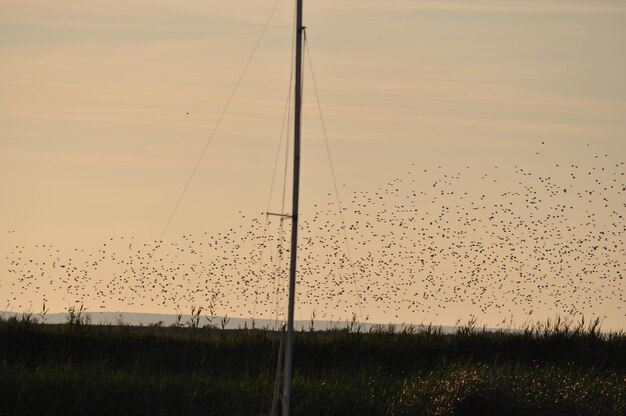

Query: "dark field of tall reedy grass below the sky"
<box><xmin>0</xmin><ymin>317</ymin><xmax>626</xmax><ymax>416</ymax></box>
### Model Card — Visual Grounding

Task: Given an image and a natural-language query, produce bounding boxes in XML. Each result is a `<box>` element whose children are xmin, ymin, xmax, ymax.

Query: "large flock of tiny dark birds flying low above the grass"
<box><xmin>0</xmin><ymin>143</ymin><xmax>626</xmax><ymax>328</ymax></box>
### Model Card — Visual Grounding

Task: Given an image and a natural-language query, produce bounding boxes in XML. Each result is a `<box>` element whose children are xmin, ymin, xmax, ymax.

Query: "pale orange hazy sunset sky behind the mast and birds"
<box><xmin>0</xmin><ymin>0</ymin><xmax>626</xmax><ymax>329</ymax></box>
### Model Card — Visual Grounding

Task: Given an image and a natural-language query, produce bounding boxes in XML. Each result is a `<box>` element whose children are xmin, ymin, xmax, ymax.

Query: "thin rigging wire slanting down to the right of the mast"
<box><xmin>304</xmin><ymin>31</ymin><xmax>364</xmax><ymax>322</ymax></box>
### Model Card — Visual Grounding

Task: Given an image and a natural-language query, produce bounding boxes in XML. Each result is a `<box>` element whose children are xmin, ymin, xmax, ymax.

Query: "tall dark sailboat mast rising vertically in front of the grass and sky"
<box><xmin>282</xmin><ymin>0</ymin><xmax>304</xmax><ymax>416</ymax></box>
